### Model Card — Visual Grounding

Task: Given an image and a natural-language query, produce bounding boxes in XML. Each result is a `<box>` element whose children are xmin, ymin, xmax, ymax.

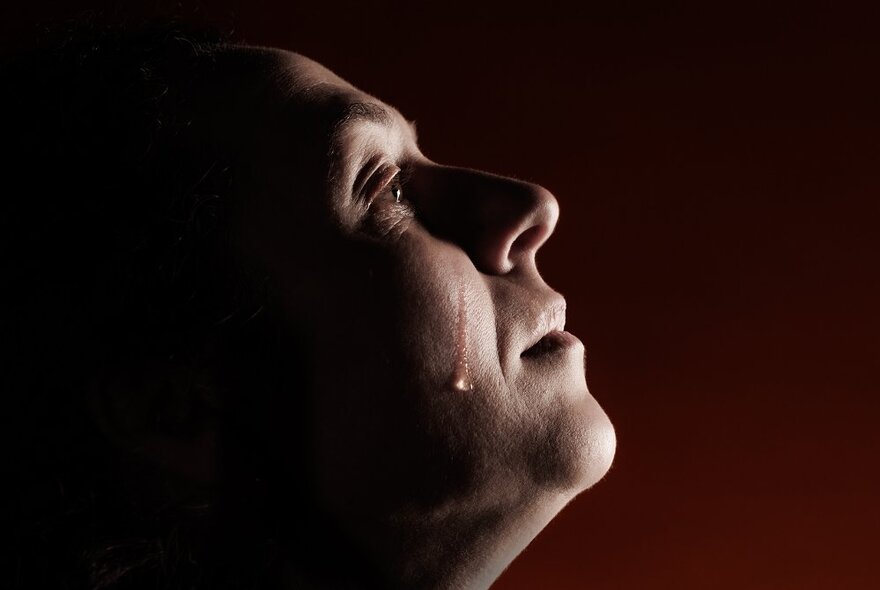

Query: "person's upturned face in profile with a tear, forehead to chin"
<box><xmin>215</xmin><ymin>49</ymin><xmax>615</xmax><ymax>556</ymax></box>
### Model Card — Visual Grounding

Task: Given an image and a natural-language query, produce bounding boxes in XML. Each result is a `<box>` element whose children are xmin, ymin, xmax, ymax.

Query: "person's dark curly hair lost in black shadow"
<box><xmin>0</xmin><ymin>23</ymin><xmax>286</xmax><ymax>589</ymax></box>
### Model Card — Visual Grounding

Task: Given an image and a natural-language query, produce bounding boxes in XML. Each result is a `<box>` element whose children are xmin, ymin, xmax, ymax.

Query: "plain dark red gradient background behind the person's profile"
<box><xmin>2</xmin><ymin>1</ymin><xmax>880</xmax><ymax>590</ymax></box>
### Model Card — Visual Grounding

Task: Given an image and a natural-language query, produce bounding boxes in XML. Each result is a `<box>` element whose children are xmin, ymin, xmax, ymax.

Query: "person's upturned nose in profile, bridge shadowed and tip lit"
<box><xmin>419</xmin><ymin>167</ymin><xmax>559</xmax><ymax>275</ymax></box>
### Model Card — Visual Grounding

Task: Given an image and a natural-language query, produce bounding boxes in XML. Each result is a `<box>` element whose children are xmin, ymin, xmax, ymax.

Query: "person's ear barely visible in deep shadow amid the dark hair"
<box><xmin>88</xmin><ymin>361</ymin><xmax>219</xmax><ymax>484</ymax></box>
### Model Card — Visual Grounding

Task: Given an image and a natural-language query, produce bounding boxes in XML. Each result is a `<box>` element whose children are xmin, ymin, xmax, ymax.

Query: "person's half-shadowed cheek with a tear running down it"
<box><xmin>304</xmin><ymin>241</ymin><xmax>511</xmax><ymax>505</ymax></box>
